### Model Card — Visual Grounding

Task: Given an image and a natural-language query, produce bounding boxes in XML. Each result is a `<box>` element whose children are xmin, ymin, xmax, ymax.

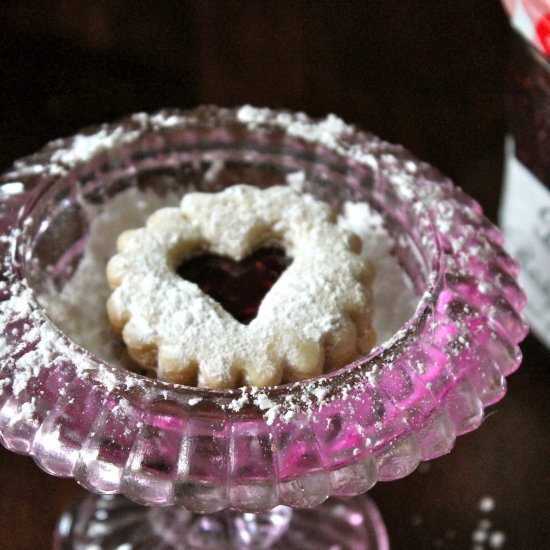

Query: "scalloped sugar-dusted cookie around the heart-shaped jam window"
<box><xmin>107</xmin><ymin>184</ymin><xmax>375</xmax><ymax>388</ymax></box>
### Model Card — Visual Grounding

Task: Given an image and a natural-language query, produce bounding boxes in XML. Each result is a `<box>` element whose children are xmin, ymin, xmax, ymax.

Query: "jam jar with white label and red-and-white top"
<box><xmin>499</xmin><ymin>0</ymin><xmax>550</xmax><ymax>348</ymax></box>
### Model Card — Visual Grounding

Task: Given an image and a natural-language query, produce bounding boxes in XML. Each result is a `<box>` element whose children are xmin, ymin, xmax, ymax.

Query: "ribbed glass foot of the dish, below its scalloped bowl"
<box><xmin>53</xmin><ymin>494</ymin><xmax>389</xmax><ymax>550</ymax></box>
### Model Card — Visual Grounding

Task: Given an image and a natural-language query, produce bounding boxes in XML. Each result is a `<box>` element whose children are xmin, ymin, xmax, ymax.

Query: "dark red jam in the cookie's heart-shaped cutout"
<box><xmin>180</xmin><ymin>247</ymin><xmax>292</xmax><ymax>325</ymax></box>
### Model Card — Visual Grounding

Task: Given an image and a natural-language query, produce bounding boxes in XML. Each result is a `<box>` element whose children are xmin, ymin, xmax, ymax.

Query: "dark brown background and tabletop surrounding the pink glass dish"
<box><xmin>0</xmin><ymin>0</ymin><xmax>550</xmax><ymax>550</ymax></box>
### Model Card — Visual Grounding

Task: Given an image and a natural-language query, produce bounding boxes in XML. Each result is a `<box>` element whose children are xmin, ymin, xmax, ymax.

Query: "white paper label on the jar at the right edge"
<box><xmin>499</xmin><ymin>140</ymin><xmax>550</xmax><ymax>347</ymax></box>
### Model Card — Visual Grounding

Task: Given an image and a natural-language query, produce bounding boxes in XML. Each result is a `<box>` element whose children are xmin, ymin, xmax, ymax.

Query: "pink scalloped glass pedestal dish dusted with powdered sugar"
<box><xmin>0</xmin><ymin>107</ymin><xmax>526</xmax><ymax>548</ymax></box>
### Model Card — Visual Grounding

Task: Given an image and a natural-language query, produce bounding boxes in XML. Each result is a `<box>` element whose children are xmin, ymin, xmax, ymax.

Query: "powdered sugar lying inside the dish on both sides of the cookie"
<box><xmin>30</xmin><ymin>188</ymin><xmax>418</xmax><ymax>388</ymax></box>
